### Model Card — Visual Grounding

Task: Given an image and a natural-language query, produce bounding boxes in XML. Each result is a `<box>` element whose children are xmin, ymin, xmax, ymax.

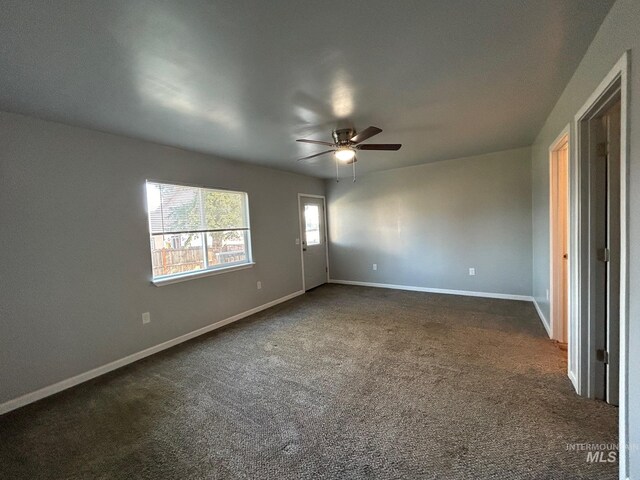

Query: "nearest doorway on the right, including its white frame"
<box><xmin>569</xmin><ymin>53</ymin><xmax>629</xmax><ymax>416</ymax></box>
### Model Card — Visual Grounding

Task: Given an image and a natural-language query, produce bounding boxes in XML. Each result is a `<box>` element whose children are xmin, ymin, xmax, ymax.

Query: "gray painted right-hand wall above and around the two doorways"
<box><xmin>532</xmin><ymin>0</ymin><xmax>640</xmax><ymax>479</ymax></box>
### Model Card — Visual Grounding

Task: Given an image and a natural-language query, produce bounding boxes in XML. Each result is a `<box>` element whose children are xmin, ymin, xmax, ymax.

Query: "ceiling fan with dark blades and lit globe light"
<box><xmin>296</xmin><ymin>126</ymin><xmax>402</xmax><ymax>182</ymax></box>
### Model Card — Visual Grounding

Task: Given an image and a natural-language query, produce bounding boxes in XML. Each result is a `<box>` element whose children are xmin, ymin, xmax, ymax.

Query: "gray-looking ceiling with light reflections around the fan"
<box><xmin>0</xmin><ymin>0</ymin><xmax>613</xmax><ymax>177</ymax></box>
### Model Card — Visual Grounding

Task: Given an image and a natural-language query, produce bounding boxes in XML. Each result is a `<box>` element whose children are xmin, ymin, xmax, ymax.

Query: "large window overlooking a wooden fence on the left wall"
<box><xmin>147</xmin><ymin>181</ymin><xmax>251</xmax><ymax>284</ymax></box>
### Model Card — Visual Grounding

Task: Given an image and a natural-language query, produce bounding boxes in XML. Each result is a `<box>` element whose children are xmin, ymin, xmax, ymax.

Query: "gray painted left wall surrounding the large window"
<box><xmin>0</xmin><ymin>113</ymin><xmax>324</xmax><ymax>403</ymax></box>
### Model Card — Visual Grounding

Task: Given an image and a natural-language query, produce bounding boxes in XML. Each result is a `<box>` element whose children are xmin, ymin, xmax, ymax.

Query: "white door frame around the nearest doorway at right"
<box><xmin>569</xmin><ymin>52</ymin><xmax>631</xmax><ymax>479</ymax></box>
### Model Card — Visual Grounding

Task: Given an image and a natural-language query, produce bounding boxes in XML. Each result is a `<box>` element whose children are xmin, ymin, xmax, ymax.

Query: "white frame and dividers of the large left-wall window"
<box><xmin>144</xmin><ymin>179</ymin><xmax>255</xmax><ymax>287</ymax></box>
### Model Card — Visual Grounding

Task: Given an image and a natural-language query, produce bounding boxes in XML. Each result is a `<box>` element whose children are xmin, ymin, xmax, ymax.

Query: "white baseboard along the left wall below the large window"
<box><xmin>0</xmin><ymin>290</ymin><xmax>304</xmax><ymax>415</ymax></box>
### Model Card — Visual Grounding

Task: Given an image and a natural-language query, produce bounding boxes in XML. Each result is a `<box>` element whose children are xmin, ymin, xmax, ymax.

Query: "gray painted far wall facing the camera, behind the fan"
<box><xmin>327</xmin><ymin>148</ymin><xmax>531</xmax><ymax>296</ymax></box>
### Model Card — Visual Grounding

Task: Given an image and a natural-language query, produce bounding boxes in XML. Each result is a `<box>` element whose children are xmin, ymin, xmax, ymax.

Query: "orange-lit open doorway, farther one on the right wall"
<box><xmin>549</xmin><ymin>126</ymin><xmax>569</xmax><ymax>344</ymax></box>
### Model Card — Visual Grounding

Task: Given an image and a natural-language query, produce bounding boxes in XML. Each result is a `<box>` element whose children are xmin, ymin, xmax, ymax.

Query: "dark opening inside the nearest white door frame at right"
<box><xmin>576</xmin><ymin>84</ymin><xmax>624</xmax><ymax>405</ymax></box>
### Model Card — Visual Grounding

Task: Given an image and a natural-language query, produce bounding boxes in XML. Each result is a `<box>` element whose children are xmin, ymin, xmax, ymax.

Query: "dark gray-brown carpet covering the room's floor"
<box><xmin>0</xmin><ymin>285</ymin><xmax>617</xmax><ymax>480</ymax></box>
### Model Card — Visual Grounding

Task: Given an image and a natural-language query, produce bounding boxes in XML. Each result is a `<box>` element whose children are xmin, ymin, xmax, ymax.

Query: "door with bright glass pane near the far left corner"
<box><xmin>299</xmin><ymin>195</ymin><xmax>328</xmax><ymax>290</ymax></box>
